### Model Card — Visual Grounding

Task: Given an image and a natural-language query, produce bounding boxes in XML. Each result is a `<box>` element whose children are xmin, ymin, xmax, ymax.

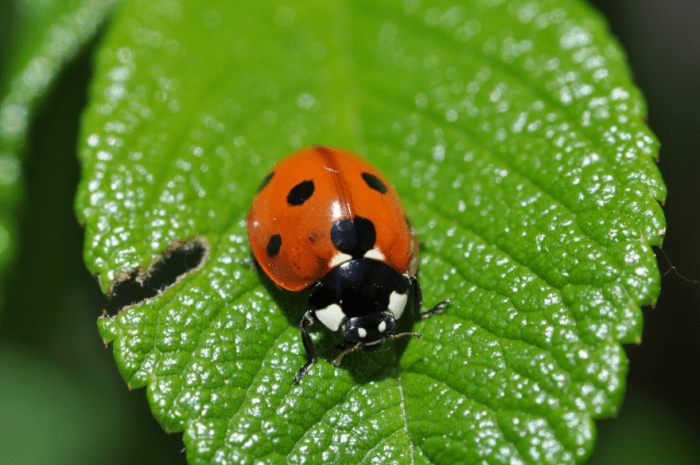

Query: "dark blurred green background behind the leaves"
<box><xmin>0</xmin><ymin>0</ymin><xmax>700</xmax><ymax>464</ymax></box>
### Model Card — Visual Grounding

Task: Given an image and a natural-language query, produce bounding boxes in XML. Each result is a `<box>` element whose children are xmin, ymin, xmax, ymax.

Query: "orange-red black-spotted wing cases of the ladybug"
<box><xmin>247</xmin><ymin>146</ymin><xmax>418</xmax><ymax>291</ymax></box>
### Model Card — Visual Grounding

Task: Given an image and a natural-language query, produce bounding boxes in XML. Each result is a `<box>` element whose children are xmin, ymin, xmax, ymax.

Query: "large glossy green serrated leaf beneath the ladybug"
<box><xmin>77</xmin><ymin>0</ymin><xmax>665</xmax><ymax>464</ymax></box>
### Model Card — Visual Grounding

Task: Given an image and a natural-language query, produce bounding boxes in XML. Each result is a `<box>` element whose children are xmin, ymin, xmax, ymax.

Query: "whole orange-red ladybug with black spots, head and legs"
<box><xmin>247</xmin><ymin>146</ymin><xmax>450</xmax><ymax>383</ymax></box>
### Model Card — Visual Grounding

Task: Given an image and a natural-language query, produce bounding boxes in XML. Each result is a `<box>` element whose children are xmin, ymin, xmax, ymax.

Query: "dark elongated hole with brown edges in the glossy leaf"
<box><xmin>105</xmin><ymin>237</ymin><xmax>209</xmax><ymax>315</ymax></box>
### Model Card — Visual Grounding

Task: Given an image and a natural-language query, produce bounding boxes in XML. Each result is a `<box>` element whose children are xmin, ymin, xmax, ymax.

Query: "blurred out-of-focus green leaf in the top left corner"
<box><xmin>0</xmin><ymin>0</ymin><xmax>115</xmax><ymax>307</ymax></box>
